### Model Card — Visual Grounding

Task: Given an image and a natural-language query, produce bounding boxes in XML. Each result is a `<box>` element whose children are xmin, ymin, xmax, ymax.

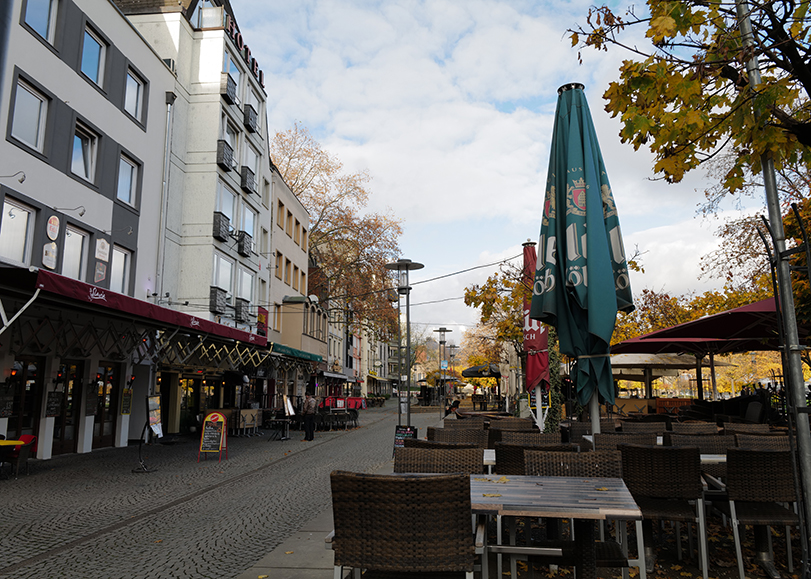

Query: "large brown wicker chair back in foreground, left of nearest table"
<box><xmin>330</xmin><ymin>472</ymin><xmax>476</xmax><ymax>579</ymax></box>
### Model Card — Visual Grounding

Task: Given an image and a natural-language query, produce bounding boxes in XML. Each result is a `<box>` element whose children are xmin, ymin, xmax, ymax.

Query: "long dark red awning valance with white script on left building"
<box><xmin>36</xmin><ymin>269</ymin><xmax>267</xmax><ymax>346</ymax></box>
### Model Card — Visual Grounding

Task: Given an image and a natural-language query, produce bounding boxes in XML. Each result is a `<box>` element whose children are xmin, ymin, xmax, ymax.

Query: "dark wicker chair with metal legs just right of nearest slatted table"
<box><xmin>619</xmin><ymin>444</ymin><xmax>709</xmax><ymax>579</ymax></box>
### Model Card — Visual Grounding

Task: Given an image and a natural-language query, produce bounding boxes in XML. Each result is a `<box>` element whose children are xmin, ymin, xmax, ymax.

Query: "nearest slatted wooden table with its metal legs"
<box><xmin>470</xmin><ymin>475</ymin><xmax>645</xmax><ymax>579</ymax></box>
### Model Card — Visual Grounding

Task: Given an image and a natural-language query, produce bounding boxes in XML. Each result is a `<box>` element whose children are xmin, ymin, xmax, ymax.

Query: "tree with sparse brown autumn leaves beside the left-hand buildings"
<box><xmin>270</xmin><ymin>124</ymin><xmax>402</xmax><ymax>338</ymax></box>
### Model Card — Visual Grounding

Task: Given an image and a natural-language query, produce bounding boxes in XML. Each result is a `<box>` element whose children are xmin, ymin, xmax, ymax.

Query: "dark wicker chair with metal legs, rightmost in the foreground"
<box><xmin>721</xmin><ymin>448</ymin><xmax>799</xmax><ymax>579</ymax></box>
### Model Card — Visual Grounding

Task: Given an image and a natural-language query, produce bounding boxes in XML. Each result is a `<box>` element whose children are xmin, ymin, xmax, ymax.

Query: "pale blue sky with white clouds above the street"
<box><xmin>231</xmin><ymin>0</ymin><xmax>760</xmax><ymax>344</ymax></box>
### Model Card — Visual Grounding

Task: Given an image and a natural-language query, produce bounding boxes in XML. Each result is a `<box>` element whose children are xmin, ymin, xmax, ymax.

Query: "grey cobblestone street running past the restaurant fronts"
<box><xmin>0</xmin><ymin>404</ymin><xmax>440</xmax><ymax>579</ymax></box>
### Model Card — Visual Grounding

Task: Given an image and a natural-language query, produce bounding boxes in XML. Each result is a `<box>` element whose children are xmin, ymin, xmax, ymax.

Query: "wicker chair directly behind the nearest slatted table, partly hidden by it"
<box><xmin>524</xmin><ymin>450</ymin><xmax>645</xmax><ymax>576</ymax></box>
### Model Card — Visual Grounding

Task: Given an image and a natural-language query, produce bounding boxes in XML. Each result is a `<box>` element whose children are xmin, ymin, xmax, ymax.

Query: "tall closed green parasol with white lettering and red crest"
<box><xmin>530</xmin><ymin>84</ymin><xmax>634</xmax><ymax>412</ymax></box>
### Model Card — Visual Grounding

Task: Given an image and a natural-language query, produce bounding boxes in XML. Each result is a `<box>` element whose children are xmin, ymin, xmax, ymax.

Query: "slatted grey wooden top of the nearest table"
<box><xmin>470</xmin><ymin>475</ymin><xmax>642</xmax><ymax>520</ymax></box>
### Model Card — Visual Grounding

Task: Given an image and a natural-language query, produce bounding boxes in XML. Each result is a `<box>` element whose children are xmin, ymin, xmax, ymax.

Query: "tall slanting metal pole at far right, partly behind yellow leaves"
<box><xmin>735</xmin><ymin>0</ymin><xmax>811</xmax><ymax>535</ymax></box>
